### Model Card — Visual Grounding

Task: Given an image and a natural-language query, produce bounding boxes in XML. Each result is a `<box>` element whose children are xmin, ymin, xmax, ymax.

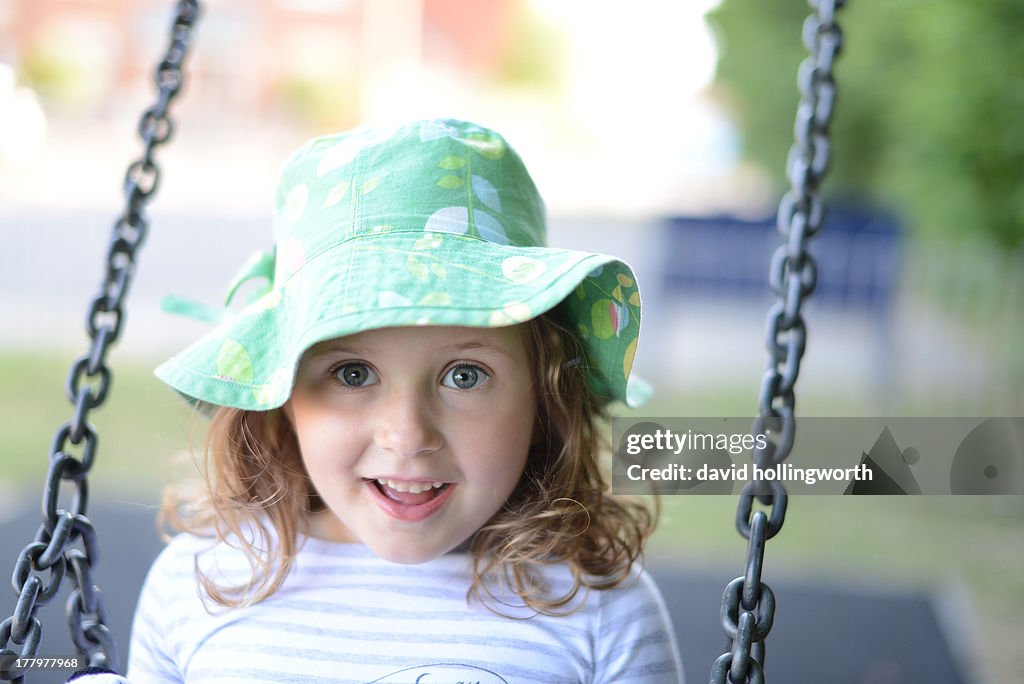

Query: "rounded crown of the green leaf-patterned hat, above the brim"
<box><xmin>274</xmin><ymin>120</ymin><xmax>547</xmax><ymax>283</ymax></box>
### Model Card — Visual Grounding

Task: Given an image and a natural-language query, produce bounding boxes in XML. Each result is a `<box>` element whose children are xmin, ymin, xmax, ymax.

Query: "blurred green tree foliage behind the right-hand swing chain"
<box><xmin>709</xmin><ymin>0</ymin><xmax>1024</xmax><ymax>248</ymax></box>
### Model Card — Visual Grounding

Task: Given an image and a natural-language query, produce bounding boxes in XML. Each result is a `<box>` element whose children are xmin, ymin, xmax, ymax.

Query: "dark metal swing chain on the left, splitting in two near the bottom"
<box><xmin>0</xmin><ymin>0</ymin><xmax>200</xmax><ymax>682</ymax></box>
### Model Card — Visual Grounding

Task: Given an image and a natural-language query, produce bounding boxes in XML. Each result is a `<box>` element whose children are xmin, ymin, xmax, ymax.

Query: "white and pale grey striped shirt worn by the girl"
<box><xmin>128</xmin><ymin>535</ymin><xmax>682</xmax><ymax>684</ymax></box>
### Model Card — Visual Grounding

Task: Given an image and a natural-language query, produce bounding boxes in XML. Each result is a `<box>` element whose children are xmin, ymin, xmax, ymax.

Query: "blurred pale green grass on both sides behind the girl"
<box><xmin>0</xmin><ymin>351</ymin><xmax>1024</xmax><ymax>681</ymax></box>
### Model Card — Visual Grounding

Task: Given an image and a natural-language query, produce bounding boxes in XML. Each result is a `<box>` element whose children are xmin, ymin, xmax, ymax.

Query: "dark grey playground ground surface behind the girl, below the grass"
<box><xmin>0</xmin><ymin>501</ymin><xmax>973</xmax><ymax>684</ymax></box>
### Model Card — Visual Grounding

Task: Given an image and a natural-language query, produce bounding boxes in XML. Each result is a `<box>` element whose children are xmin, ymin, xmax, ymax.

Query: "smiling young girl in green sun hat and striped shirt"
<box><xmin>83</xmin><ymin>120</ymin><xmax>682</xmax><ymax>684</ymax></box>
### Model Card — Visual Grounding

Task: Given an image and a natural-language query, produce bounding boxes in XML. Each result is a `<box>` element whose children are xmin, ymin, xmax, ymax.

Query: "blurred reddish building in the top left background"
<box><xmin>0</xmin><ymin>0</ymin><xmax>523</xmax><ymax>125</ymax></box>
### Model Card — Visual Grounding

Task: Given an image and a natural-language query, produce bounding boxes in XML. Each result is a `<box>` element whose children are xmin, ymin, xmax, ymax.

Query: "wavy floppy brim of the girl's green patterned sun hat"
<box><xmin>156</xmin><ymin>231</ymin><xmax>640</xmax><ymax>411</ymax></box>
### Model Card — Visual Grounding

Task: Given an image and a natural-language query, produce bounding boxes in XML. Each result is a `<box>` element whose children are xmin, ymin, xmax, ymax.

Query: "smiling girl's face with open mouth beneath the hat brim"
<box><xmin>284</xmin><ymin>326</ymin><xmax>536</xmax><ymax>563</ymax></box>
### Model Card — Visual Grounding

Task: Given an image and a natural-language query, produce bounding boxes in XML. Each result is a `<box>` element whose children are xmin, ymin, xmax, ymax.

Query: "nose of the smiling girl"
<box><xmin>374</xmin><ymin>388</ymin><xmax>443</xmax><ymax>457</ymax></box>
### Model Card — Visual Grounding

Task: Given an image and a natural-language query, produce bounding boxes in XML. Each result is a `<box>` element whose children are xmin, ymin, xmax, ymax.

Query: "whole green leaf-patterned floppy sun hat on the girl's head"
<box><xmin>156</xmin><ymin>120</ymin><xmax>645</xmax><ymax>411</ymax></box>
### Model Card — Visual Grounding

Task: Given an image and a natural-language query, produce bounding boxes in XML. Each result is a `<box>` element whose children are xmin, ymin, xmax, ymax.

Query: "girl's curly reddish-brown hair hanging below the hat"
<box><xmin>162</xmin><ymin>312</ymin><xmax>657</xmax><ymax>614</ymax></box>
